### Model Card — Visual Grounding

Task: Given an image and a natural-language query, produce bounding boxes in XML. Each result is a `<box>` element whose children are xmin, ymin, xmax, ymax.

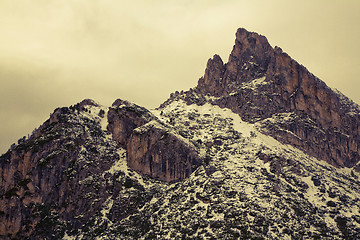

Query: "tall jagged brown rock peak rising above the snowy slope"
<box><xmin>194</xmin><ymin>29</ymin><xmax>360</xmax><ymax>167</ymax></box>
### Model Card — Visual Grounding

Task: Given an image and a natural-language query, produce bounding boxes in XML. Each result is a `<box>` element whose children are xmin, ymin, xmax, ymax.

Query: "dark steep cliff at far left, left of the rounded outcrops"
<box><xmin>0</xmin><ymin>100</ymin><xmax>119</xmax><ymax>239</ymax></box>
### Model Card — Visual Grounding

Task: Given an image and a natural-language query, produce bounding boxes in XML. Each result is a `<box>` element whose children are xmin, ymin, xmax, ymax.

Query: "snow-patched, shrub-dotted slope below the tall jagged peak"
<box><xmin>74</xmin><ymin>100</ymin><xmax>360</xmax><ymax>239</ymax></box>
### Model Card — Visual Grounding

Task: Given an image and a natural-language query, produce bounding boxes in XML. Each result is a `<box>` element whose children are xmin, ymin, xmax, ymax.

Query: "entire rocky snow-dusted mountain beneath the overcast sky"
<box><xmin>0</xmin><ymin>28</ymin><xmax>360</xmax><ymax>239</ymax></box>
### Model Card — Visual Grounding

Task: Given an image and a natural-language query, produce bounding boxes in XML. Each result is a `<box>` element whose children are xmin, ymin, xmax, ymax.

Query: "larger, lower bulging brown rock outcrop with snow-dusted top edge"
<box><xmin>127</xmin><ymin>122</ymin><xmax>201</xmax><ymax>182</ymax></box>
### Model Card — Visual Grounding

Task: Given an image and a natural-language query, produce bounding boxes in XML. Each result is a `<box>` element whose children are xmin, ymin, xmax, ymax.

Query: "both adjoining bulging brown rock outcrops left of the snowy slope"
<box><xmin>108</xmin><ymin>100</ymin><xmax>202</xmax><ymax>182</ymax></box>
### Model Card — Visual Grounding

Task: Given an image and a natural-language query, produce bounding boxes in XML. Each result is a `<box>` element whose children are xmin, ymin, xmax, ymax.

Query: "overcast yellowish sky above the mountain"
<box><xmin>0</xmin><ymin>0</ymin><xmax>360</xmax><ymax>154</ymax></box>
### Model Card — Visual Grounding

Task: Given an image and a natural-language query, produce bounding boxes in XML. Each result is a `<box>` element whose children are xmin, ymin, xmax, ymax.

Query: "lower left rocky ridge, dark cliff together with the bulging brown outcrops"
<box><xmin>0</xmin><ymin>99</ymin><xmax>202</xmax><ymax>239</ymax></box>
